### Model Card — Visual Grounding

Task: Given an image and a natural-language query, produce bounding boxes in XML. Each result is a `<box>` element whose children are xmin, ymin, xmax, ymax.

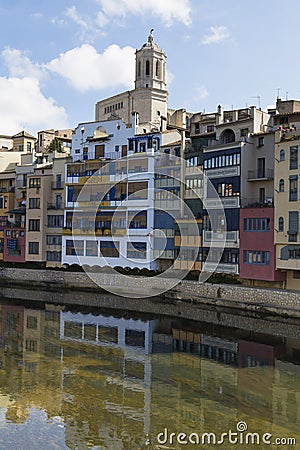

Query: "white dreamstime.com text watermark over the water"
<box><xmin>151</xmin><ymin>421</ymin><xmax>296</xmax><ymax>448</ymax></box>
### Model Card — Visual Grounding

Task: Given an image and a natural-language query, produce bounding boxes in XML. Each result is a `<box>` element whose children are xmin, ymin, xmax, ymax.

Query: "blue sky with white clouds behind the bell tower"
<box><xmin>0</xmin><ymin>0</ymin><xmax>300</xmax><ymax>135</ymax></box>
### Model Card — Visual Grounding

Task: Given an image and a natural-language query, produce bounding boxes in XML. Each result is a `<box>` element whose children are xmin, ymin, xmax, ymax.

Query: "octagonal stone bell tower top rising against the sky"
<box><xmin>135</xmin><ymin>30</ymin><xmax>167</xmax><ymax>90</ymax></box>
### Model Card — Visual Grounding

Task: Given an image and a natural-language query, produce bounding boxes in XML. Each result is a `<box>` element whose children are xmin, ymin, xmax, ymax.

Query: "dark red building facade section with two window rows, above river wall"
<box><xmin>239</xmin><ymin>206</ymin><xmax>286</xmax><ymax>282</ymax></box>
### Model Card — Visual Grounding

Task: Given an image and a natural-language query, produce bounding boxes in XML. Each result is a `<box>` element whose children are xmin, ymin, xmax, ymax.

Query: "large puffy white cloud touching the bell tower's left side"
<box><xmin>45</xmin><ymin>44</ymin><xmax>135</xmax><ymax>92</ymax></box>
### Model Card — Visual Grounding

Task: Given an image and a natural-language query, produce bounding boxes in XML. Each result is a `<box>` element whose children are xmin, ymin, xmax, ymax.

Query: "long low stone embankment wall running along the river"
<box><xmin>0</xmin><ymin>268</ymin><xmax>300</xmax><ymax>317</ymax></box>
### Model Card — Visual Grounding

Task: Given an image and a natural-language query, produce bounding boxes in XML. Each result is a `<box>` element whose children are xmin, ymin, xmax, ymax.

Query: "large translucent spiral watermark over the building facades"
<box><xmin>72</xmin><ymin>153</ymin><xmax>226</xmax><ymax>298</ymax></box>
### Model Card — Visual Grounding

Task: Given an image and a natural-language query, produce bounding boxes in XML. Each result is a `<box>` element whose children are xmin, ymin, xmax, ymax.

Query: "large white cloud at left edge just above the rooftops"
<box><xmin>0</xmin><ymin>77</ymin><xmax>68</xmax><ymax>134</ymax></box>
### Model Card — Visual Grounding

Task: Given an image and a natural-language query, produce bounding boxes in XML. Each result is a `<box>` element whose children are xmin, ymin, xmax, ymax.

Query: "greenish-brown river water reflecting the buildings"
<box><xmin>0</xmin><ymin>298</ymin><xmax>300</xmax><ymax>450</ymax></box>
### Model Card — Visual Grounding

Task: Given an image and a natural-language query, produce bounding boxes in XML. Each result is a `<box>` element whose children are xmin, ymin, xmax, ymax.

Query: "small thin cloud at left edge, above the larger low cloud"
<box><xmin>1</xmin><ymin>47</ymin><xmax>45</xmax><ymax>79</ymax></box>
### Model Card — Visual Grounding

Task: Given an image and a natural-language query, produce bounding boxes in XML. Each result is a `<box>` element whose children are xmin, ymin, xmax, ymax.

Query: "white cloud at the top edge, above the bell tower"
<box><xmin>98</xmin><ymin>0</ymin><xmax>192</xmax><ymax>27</ymax></box>
